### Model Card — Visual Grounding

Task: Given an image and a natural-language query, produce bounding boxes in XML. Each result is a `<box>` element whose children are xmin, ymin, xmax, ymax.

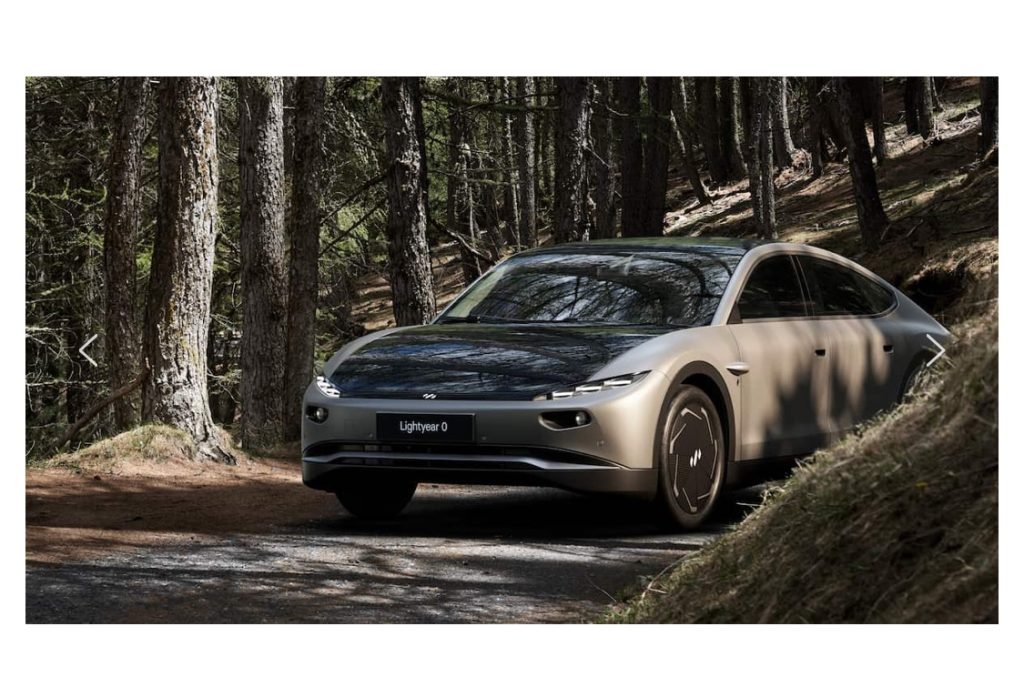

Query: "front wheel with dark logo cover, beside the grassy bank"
<box><xmin>656</xmin><ymin>384</ymin><xmax>728</xmax><ymax>529</ymax></box>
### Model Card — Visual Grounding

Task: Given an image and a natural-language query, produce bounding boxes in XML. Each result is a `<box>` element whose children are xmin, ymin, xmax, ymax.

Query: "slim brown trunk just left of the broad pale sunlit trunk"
<box><xmin>103</xmin><ymin>77</ymin><xmax>150</xmax><ymax>432</ymax></box>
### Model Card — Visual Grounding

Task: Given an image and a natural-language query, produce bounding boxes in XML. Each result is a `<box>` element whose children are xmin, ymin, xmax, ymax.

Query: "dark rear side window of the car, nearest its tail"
<box><xmin>800</xmin><ymin>257</ymin><xmax>894</xmax><ymax>315</ymax></box>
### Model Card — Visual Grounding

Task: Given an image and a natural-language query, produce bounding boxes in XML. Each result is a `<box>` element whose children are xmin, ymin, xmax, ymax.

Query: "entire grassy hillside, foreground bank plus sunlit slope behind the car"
<box><xmin>603</xmin><ymin>79</ymin><xmax>998</xmax><ymax>622</ymax></box>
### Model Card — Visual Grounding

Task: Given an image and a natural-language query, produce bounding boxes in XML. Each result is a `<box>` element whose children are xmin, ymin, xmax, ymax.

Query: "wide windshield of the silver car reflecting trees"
<box><xmin>440</xmin><ymin>247</ymin><xmax>742</xmax><ymax>327</ymax></box>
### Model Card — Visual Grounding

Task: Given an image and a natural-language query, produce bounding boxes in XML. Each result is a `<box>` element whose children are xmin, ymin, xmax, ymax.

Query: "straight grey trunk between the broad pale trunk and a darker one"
<box><xmin>239</xmin><ymin>77</ymin><xmax>288</xmax><ymax>448</ymax></box>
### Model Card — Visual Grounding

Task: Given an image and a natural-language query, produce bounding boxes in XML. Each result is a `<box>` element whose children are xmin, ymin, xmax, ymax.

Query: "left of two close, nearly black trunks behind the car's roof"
<box><xmin>614</xmin><ymin>77</ymin><xmax>644</xmax><ymax>237</ymax></box>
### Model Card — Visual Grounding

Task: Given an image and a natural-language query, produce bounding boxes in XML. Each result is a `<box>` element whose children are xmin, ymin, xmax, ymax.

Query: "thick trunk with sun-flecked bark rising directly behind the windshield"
<box><xmin>554</xmin><ymin>77</ymin><xmax>590</xmax><ymax>244</ymax></box>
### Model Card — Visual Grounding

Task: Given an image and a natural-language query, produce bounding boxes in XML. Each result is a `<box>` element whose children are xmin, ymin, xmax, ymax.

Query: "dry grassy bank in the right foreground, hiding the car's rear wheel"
<box><xmin>606</xmin><ymin>320</ymin><xmax>998</xmax><ymax>622</ymax></box>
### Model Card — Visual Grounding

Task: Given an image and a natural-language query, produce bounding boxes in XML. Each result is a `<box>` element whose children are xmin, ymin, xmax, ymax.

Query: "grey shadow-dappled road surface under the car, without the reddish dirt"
<box><xmin>26</xmin><ymin>485</ymin><xmax>758</xmax><ymax>622</ymax></box>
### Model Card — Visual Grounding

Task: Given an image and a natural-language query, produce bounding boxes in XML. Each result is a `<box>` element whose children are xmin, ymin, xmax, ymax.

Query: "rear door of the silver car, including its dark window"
<box><xmin>798</xmin><ymin>256</ymin><xmax>909</xmax><ymax>432</ymax></box>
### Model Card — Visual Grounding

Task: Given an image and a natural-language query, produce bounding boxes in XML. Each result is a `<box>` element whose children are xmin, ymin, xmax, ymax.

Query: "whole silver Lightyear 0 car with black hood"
<box><xmin>302</xmin><ymin>238</ymin><xmax>949</xmax><ymax>528</ymax></box>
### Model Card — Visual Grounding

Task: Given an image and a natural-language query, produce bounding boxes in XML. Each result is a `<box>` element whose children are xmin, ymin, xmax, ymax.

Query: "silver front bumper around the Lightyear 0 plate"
<box><xmin>302</xmin><ymin>373</ymin><xmax>668</xmax><ymax>497</ymax></box>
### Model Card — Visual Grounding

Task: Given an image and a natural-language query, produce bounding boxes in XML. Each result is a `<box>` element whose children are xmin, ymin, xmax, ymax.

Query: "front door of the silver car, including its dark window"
<box><xmin>729</xmin><ymin>255</ymin><xmax>831</xmax><ymax>460</ymax></box>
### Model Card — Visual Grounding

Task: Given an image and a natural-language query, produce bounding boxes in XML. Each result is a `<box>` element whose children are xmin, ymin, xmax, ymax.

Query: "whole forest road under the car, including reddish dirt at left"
<box><xmin>26</xmin><ymin>462</ymin><xmax>758</xmax><ymax>622</ymax></box>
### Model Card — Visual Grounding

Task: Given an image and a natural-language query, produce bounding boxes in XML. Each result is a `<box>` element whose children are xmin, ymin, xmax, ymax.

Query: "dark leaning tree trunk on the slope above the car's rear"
<box><xmin>836</xmin><ymin>78</ymin><xmax>889</xmax><ymax>250</ymax></box>
